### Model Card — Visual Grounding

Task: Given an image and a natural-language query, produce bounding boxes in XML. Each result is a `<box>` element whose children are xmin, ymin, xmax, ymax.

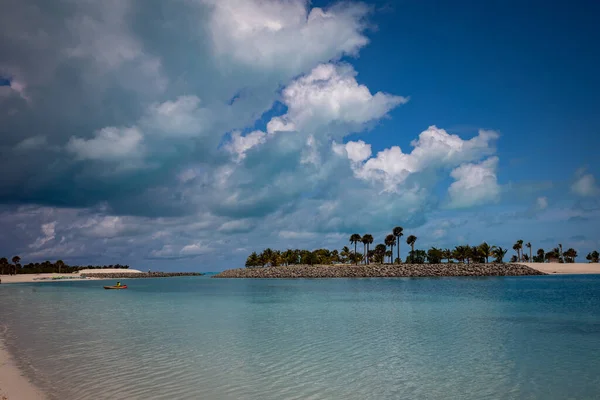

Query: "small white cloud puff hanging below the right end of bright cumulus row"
<box><xmin>448</xmin><ymin>157</ymin><xmax>500</xmax><ymax>208</ymax></box>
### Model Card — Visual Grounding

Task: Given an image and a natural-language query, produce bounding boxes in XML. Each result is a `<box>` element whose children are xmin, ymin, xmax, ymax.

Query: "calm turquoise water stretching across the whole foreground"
<box><xmin>0</xmin><ymin>276</ymin><xmax>600</xmax><ymax>400</ymax></box>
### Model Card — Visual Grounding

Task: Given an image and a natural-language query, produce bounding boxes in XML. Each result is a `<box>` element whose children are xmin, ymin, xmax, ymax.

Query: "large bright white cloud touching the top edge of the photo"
<box><xmin>202</xmin><ymin>0</ymin><xmax>368</xmax><ymax>76</ymax></box>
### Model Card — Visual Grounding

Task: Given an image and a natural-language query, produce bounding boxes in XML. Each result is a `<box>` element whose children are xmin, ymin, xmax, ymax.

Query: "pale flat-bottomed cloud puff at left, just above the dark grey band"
<box><xmin>67</xmin><ymin>127</ymin><xmax>143</xmax><ymax>161</ymax></box>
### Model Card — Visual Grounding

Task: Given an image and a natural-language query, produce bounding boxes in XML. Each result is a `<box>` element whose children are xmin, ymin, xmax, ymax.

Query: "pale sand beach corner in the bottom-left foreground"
<box><xmin>0</xmin><ymin>340</ymin><xmax>45</xmax><ymax>400</ymax></box>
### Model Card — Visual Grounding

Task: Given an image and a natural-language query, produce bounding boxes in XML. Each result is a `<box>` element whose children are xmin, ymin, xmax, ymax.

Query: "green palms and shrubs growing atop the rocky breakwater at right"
<box><xmin>246</xmin><ymin>226</ymin><xmax>600</xmax><ymax>267</ymax></box>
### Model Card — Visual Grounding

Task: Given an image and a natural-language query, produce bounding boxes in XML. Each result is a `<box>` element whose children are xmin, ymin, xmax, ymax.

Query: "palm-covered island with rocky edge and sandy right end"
<box><xmin>213</xmin><ymin>226</ymin><xmax>600</xmax><ymax>278</ymax></box>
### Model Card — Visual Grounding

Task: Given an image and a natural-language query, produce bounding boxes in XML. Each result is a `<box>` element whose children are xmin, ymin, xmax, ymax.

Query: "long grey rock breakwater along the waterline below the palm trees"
<box><xmin>213</xmin><ymin>263</ymin><xmax>546</xmax><ymax>279</ymax></box>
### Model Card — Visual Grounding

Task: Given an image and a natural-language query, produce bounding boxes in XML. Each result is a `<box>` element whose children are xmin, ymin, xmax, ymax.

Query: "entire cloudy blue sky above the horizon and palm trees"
<box><xmin>0</xmin><ymin>0</ymin><xmax>600</xmax><ymax>271</ymax></box>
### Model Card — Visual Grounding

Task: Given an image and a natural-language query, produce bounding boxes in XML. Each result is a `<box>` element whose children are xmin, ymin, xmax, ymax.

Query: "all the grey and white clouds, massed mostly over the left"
<box><xmin>0</xmin><ymin>0</ymin><xmax>595</xmax><ymax>266</ymax></box>
